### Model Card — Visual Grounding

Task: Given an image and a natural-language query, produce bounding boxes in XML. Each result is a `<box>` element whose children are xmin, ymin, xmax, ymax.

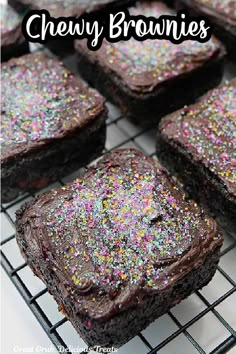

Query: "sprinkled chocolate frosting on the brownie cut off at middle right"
<box><xmin>160</xmin><ymin>78</ymin><xmax>236</xmax><ymax>197</ymax></box>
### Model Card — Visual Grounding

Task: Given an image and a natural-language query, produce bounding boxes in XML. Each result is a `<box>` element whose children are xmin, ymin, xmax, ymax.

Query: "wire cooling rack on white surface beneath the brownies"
<box><xmin>1</xmin><ymin>38</ymin><xmax>236</xmax><ymax>354</ymax></box>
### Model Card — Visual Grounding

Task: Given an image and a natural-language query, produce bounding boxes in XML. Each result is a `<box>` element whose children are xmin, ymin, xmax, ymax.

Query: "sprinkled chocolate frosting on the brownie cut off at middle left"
<box><xmin>1</xmin><ymin>53</ymin><xmax>105</xmax><ymax>162</ymax></box>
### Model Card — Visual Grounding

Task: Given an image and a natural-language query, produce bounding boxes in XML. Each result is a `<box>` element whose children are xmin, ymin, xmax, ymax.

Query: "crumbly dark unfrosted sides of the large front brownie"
<box><xmin>17</xmin><ymin>209</ymin><xmax>220</xmax><ymax>348</ymax></box>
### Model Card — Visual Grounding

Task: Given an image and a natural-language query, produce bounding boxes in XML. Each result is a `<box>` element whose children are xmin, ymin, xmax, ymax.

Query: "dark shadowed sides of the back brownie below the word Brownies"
<box><xmin>76</xmin><ymin>41</ymin><xmax>224</xmax><ymax>127</ymax></box>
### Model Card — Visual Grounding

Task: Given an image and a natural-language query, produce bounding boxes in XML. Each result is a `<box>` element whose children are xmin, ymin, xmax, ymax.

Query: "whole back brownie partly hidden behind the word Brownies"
<box><xmin>75</xmin><ymin>1</ymin><xmax>224</xmax><ymax>125</ymax></box>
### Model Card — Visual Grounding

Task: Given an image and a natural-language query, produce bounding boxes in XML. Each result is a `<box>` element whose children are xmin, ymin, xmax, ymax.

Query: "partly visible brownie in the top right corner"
<box><xmin>175</xmin><ymin>0</ymin><xmax>236</xmax><ymax>60</ymax></box>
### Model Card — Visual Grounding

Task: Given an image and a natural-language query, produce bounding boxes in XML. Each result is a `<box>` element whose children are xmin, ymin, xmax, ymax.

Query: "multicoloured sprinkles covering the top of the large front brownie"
<box><xmin>45</xmin><ymin>150</ymin><xmax>214</xmax><ymax>296</ymax></box>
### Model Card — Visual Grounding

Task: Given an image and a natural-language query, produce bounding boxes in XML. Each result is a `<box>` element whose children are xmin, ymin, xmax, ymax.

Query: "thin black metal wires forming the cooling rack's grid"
<box><xmin>1</xmin><ymin>46</ymin><xmax>236</xmax><ymax>354</ymax></box>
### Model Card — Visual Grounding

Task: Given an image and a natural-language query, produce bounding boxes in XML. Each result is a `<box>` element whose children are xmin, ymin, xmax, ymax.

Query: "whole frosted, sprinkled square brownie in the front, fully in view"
<box><xmin>16</xmin><ymin>149</ymin><xmax>223</xmax><ymax>347</ymax></box>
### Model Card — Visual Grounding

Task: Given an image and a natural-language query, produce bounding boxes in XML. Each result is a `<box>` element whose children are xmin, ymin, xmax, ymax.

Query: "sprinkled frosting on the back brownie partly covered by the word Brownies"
<box><xmin>75</xmin><ymin>1</ymin><xmax>223</xmax><ymax>93</ymax></box>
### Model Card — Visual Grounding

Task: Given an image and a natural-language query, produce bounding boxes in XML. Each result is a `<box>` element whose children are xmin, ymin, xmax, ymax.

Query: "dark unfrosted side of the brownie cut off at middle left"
<box><xmin>1</xmin><ymin>117</ymin><xmax>106</xmax><ymax>203</ymax></box>
